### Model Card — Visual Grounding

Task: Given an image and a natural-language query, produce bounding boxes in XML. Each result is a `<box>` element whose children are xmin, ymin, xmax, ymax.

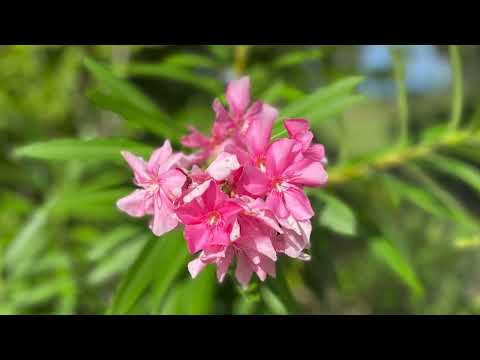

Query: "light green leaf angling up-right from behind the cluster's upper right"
<box><xmin>272</xmin><ymin>76</ymin><xmax>364</xmax><ymax>139</ymax></box>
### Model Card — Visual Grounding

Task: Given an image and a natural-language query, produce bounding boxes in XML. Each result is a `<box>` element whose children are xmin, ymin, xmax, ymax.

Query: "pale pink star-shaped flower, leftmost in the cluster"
<box><xmin>117</xmin><ymin>140</ymin><xmax>186</xmax><ymax>236</ymax></box>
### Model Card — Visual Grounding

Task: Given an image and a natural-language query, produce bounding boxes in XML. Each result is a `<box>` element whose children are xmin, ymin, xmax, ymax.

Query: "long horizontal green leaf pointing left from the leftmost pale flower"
<box><xmin>14</xmin><ymin>138</ymin><xmax>153</xmax><ymax>161</ymax></box>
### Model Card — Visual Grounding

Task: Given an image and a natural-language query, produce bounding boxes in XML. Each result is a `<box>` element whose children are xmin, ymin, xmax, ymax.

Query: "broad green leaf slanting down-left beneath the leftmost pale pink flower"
<box><xmin>108</xmin><ymin>231</ymin><xmax>187</xmax><ymax>314</ymax></box>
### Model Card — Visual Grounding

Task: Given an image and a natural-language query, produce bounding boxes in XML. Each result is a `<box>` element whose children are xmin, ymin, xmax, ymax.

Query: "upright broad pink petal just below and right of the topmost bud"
<box><xmin>245</xmin><ymin>104</ymin><xmax>278</xmax><ymax>155</ymax></box>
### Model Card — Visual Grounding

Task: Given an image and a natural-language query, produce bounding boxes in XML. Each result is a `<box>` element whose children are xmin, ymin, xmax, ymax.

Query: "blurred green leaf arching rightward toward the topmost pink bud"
<box><xmin>126</xmin><ymin>63</ymin><xmax>223</xmax><ymax>96</ymax></box>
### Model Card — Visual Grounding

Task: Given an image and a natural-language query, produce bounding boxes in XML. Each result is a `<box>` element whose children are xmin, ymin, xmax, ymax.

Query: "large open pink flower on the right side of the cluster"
<box><xmin>241</xmin><ymin>139</ymin><xmax>327</xmax><ymax>220</ymax></box>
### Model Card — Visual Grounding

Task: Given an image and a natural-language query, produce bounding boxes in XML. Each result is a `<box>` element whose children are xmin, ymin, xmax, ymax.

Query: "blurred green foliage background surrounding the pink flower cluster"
<box><xmin>0</xmin><ymin>45</ymin><xmax>480</xmax><ymax>314</ymax></box>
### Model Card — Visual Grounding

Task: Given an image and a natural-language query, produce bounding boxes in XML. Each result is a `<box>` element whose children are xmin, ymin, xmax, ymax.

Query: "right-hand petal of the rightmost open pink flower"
<box><xmin>284</xmin><ymin>159</ymin><xmax>328</xmax><ymax>187</ymax></box>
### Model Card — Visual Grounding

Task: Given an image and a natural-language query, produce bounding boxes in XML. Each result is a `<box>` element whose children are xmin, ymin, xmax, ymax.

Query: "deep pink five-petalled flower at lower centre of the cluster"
<box><xmin>176</xmin><ymin>181</ymin><xmax>242</xmax><ymax>253</ymax></box>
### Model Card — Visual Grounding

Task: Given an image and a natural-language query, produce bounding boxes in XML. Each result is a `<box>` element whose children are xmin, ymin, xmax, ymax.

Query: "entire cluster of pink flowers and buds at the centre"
<box><xmin>117</xmin><ymin>77</ymin><xmax>327</xmax><ymax>286</ymax></box>
